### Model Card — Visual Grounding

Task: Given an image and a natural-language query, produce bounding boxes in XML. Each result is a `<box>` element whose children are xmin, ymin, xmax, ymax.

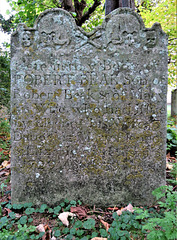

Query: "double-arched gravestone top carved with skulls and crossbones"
<box><xmin>11</xmin><ymin>8</ymin><xmax>165</xmax><ymax>56</ymax></box>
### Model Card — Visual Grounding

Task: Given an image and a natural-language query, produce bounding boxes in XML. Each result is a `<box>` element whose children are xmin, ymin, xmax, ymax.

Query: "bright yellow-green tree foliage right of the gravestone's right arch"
<box><xmin>139</xmin><ymin>0</ymin><xmax>177</xmax><ymax>86</ymax></box>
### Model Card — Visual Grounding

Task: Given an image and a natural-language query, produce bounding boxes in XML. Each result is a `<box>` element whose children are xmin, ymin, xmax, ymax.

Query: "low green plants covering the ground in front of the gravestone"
<box><xmin>0</xmin><ymin>186</ymin><xmax>177</xmax><ymax>240</ymax></box>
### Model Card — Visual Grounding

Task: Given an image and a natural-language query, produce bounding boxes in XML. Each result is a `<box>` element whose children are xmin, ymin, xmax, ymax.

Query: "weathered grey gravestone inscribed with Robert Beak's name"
<box><xmin>11</xmin><ymin>8</ymin><xmax>167</xmax><ymax>206</ymax></box>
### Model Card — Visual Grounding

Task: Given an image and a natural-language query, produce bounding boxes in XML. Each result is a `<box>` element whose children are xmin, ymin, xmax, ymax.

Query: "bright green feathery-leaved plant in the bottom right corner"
<box><xmin>136</xmin><ymin>186</ymin><xmax>177</xmax><ymax>240</ymax></box>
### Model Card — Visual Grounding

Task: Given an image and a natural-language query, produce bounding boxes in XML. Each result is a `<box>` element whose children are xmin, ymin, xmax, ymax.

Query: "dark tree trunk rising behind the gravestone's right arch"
<box><xmin>105</xmin><ymin>0</ymin><xmax>135</xmax><ymax>15</ymax></box>
